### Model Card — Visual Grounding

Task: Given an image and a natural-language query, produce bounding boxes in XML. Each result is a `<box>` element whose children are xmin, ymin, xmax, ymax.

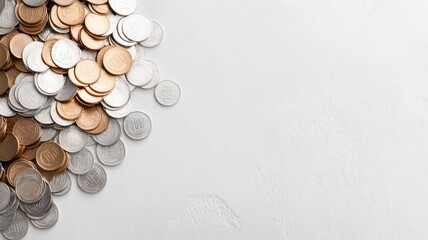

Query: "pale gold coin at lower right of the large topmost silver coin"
<box><xmin>74</xmin><ymin>59</ymin><xmax>101</xmax><ymax>85</ymax></box>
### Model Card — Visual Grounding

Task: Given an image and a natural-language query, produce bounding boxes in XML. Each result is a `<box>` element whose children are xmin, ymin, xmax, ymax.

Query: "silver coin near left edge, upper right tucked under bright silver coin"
<box><xmin>16</xmin><ymin>83</ymin><xmax>47</xmax><ymax>110</ymax></box>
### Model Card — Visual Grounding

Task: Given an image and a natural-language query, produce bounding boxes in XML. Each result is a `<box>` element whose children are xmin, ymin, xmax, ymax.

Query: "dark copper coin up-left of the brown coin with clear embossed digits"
<box><xmin>13</xmin><ymin>118</ymin><xmax>42</xmax><ymax>146</ymax></box>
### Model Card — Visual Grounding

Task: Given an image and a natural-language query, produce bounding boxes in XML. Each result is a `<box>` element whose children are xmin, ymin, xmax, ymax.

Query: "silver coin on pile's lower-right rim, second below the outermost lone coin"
<box><xmin>96</xmin><ymin>140</ymin><xmax>126</xmax><ymax>166</ymax></box>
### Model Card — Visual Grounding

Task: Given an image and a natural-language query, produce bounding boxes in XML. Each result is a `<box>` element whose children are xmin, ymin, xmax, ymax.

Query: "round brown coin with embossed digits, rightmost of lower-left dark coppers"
<box><xmin>36</xmin><ymin>142</ymin><xmax>66</xmax><ymax>172</ymax></box>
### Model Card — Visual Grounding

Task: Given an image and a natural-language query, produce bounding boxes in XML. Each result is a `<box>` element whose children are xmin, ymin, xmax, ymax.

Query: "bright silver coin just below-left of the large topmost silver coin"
<box><xmin>34</xmin><ymin>69</ymin><xmax>66</xmax><ymax>96</ymax></box>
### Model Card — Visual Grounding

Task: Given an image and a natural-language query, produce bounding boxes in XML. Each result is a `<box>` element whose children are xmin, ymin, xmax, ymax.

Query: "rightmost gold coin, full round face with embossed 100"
<box><xmin>103</xmin><ymin>46</ymin><xmax>132</xmax><ymax>75</ymax></box>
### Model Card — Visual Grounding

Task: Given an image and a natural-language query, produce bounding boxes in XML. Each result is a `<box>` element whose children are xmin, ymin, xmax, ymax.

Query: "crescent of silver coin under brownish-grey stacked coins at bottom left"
<box><xmin>21</xmin><ymin>182</ymin><xmax>52</xmax><ymax>219</ymax></box>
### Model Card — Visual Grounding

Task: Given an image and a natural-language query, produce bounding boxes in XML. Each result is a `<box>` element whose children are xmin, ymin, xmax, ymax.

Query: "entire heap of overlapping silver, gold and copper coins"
<box><xmin>0</xmin><ymin>0</ymin><xmax>181</xmax><ymax>239</ymax></box>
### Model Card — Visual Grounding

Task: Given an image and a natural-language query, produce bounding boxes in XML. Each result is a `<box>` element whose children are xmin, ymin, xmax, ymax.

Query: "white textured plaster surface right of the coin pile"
<box><xmin>23</xmin><ymin>0</ymin><xmax>428</xmax><ymax>240</ymax></box>
